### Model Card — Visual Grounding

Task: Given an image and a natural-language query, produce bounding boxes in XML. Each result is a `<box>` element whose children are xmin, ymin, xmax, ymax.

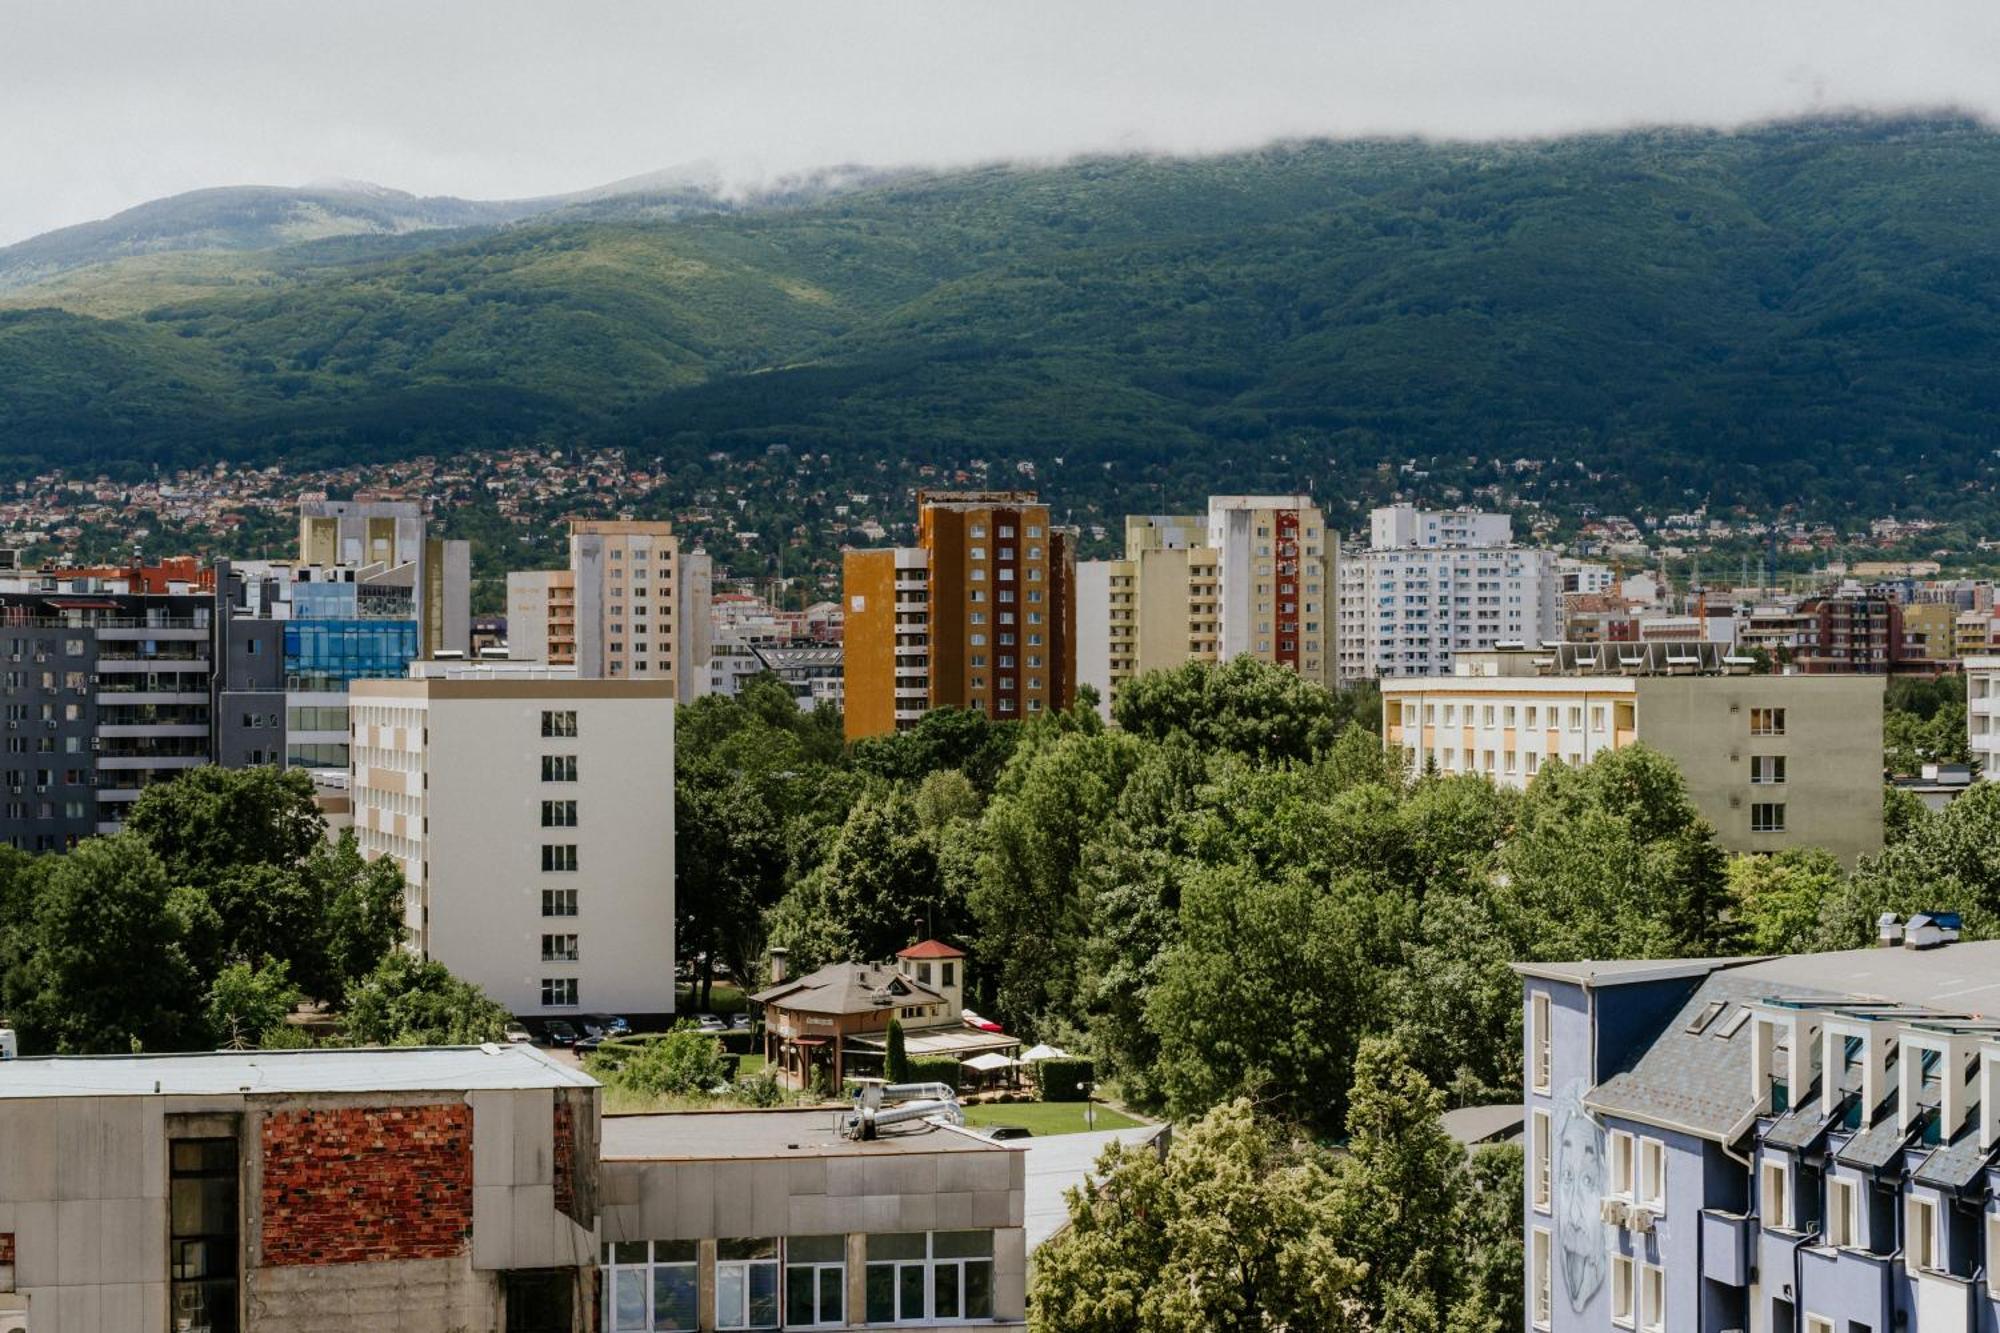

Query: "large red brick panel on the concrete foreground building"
<box><xmin>262</xmin><ymin>1105</ymin><xmax>472</xmax><ymax>1267</ymax></box>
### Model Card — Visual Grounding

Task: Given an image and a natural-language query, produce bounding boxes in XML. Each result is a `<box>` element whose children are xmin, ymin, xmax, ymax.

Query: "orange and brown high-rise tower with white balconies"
<box><xmin>842</xmin><ymin>490</ymin><xmax>1076</xmax><ymax>741</ymax></box>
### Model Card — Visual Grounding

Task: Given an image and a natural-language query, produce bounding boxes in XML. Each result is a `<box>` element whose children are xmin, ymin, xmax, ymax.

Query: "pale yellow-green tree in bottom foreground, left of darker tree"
<box><xmin>1028</xmin><ymin>1099</ymin><xmax>1362</xmax><ymax>1333</ymax></box>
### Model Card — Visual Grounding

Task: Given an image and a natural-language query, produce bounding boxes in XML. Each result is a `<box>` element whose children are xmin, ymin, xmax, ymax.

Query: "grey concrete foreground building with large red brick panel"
<box><xmin>0</xmin><ymin>1047</ymin><xmax>600</xmax><ymax>1333</ymax></box>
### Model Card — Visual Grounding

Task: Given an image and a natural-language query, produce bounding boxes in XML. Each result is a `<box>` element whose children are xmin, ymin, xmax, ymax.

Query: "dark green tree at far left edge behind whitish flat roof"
<box><xmin>4</xmin><ymin>833</ymin><xmax>202</xmax><ymax>1055</ymax></box>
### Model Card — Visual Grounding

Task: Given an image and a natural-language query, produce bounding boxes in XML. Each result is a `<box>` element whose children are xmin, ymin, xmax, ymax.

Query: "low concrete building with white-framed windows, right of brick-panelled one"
<box><xmin>602</xmin><ymin>1109</ymin><xmax>1032</xmax><ymax>1333</ymax></box>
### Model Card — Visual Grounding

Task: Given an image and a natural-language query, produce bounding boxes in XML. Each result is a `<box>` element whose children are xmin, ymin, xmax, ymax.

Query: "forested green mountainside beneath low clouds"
<box><xmin>0</xmin><ymin>120</ymin><xmax>2000</xmax><ymax>510</ymax></box>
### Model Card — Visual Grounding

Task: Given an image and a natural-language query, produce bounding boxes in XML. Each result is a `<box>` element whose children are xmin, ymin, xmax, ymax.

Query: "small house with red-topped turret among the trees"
<box><xmin>750</xmin><ymin>939</ymin><xmax>1020</xmax><ymax>1087</ymax></box>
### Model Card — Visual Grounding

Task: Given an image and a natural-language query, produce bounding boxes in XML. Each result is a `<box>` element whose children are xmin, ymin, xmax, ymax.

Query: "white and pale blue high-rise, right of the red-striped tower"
<box><xmin>1340</xmin><ymin>504</ymin><xmax>1562</xmax><ymax>681</ymax></box>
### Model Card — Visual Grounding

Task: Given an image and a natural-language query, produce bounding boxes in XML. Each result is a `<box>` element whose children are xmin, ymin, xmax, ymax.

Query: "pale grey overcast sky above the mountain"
<box><xmin>0</xmin><ymin>0</ymin><xmax>2000</xmax><ymax>244</ymax></box>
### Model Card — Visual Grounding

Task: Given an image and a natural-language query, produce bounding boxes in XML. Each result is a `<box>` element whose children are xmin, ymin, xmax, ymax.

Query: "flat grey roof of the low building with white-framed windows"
<box><xmin>598</xmin><ymin>1107</ymin><xmax>1000</xmax><ymax>1161</ymax></box>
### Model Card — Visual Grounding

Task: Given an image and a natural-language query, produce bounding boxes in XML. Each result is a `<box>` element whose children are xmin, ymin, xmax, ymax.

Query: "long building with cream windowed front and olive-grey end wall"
<box><xmin>1382</xmin><ymin>642</ymin><xmax>1882</xmax><ymax>865</ymax></box>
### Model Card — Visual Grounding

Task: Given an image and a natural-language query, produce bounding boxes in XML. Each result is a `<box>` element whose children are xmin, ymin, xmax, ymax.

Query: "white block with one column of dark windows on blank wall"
<box><xmin>350</xmin><ymin>662</ymin><xmax>674</xmax><ymax>1019</ymax></box>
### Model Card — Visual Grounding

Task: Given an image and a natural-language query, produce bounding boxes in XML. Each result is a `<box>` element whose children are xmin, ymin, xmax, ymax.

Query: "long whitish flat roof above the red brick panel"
<box><xmin>0</xmin><ymin>1043</ymin><xmax>598</xmax><ymax>1097</ymax></box>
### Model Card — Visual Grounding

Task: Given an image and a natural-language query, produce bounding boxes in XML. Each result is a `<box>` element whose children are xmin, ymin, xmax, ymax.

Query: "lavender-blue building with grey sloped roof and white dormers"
<box><xmin>1516</xmin><ymin>917</ymin><xmax>2000</xmax><ymax>1333</ymax></box>
